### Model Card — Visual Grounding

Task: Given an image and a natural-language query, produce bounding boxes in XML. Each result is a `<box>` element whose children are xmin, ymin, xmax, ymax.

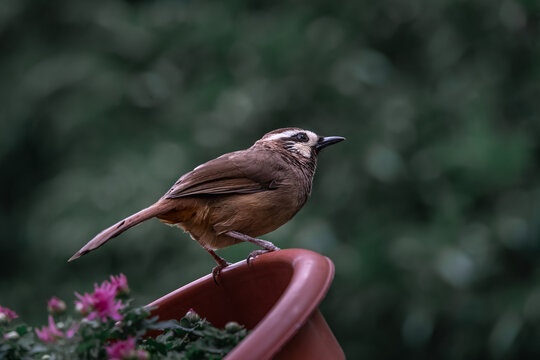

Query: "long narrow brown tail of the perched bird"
<box><xmin>68</xmin><ymin>203</ymin><xmax>168</xmax><ymax>261</ymax></box>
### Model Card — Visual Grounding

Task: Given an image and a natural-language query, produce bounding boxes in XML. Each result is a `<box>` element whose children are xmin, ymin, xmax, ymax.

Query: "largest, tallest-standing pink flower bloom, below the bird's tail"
<box><xmin>75</xmin><ymin>281</ymin><xmax>124</xmax><ymax>322</ymax></box>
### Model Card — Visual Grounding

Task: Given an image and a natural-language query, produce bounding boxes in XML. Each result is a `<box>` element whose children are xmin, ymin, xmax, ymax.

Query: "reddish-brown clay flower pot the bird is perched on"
<box><xmin>150</xmin><ymin>249</ymin><xmax>345</xmax><ymax>360</ymax></box>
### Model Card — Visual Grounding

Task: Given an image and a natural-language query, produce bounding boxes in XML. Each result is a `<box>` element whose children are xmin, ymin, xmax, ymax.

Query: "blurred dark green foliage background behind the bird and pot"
<box><xmin>0</xmin><ymin>0</ymin><xmax>540</xmax><ymax>359</ymax></box>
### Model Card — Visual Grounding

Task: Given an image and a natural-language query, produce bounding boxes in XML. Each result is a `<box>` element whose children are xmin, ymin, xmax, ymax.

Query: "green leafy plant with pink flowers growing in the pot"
<box><xmin>0</xmin><ymin>277</ymin><xmax>247</xmax><ymax>360</ymax></box>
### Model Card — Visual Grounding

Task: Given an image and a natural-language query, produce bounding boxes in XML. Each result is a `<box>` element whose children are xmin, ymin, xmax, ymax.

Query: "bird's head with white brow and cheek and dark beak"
<box><xmin>257</xmin><ymin>128</ymin><xmax>345</xmax><ymax>159</ymax></box>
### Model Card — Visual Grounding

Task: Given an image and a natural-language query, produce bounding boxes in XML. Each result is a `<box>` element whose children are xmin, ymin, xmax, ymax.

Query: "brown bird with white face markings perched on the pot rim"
<box><xmin>69</xmin><ymin>128</ymin><xmax>345</xmax><ymax>279</ymax></box>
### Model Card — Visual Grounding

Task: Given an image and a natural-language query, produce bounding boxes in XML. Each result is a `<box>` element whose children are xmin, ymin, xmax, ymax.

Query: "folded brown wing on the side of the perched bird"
<box><xmin>164</xmin><ymin>150</ymin><xmax>279</xmax><ymax>199</ymax></box>
